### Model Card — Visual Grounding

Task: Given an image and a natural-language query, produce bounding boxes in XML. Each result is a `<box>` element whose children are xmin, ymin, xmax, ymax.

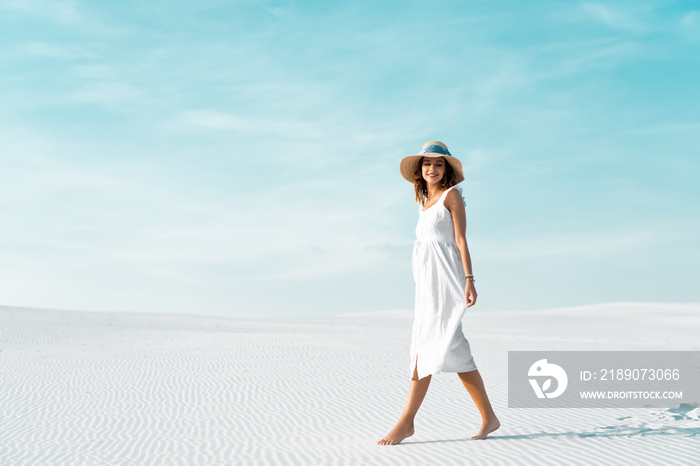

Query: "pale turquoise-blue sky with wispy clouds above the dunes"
<box><xmin>0</xmin><ymin>0</ymin><xmax>700</xmax><ymax>317</ymax></box>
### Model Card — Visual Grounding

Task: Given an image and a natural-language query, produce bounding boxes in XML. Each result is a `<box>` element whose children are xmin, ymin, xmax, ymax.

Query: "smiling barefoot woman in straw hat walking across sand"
<box><xmin>377</xmin><ymin>141</ymin><xmax>501</xmax><ymax>445</ymax></box>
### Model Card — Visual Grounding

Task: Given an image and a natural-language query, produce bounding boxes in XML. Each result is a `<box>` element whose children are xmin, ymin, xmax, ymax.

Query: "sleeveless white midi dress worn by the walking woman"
<box><xmin>411</xmin><ymin>186</ymin><xmax>476</xmax><ymax>379</ymax></box>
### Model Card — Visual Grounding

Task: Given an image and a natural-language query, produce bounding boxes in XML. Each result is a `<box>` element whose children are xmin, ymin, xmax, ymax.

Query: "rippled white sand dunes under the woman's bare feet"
<box><xmin>0</xmin><ymin>303</ymin><xmax>700</xmax><ymax>465</ymax></box>
